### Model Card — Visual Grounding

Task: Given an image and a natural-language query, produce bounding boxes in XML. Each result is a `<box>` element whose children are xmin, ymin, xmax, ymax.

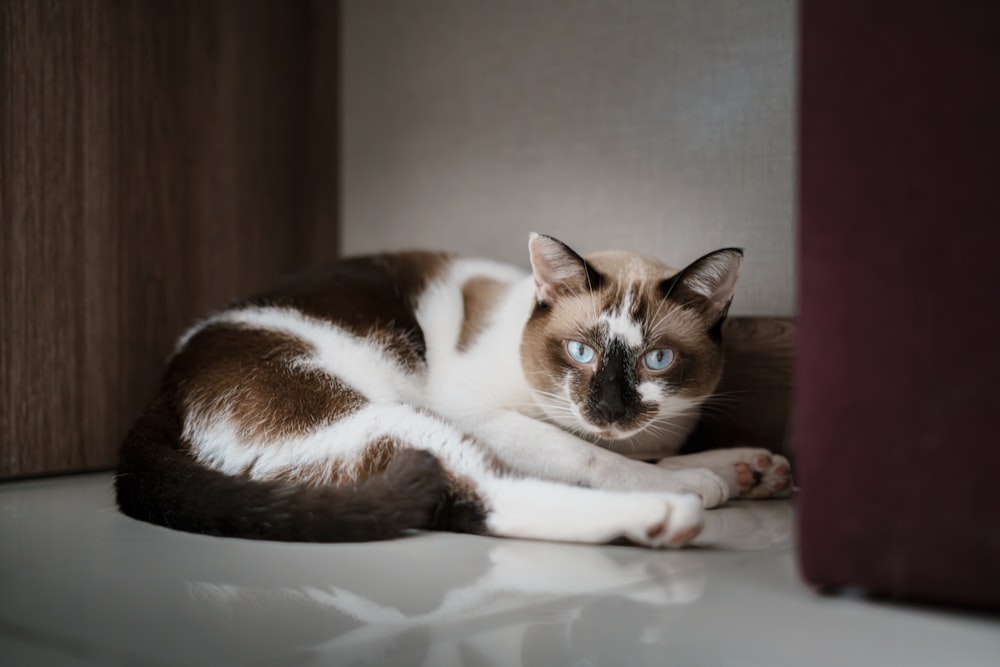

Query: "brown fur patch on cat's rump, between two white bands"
<box><xmin>170</xmin><ymin>324</ymin><xmax>366</xmax><ymax>441</ymax></box>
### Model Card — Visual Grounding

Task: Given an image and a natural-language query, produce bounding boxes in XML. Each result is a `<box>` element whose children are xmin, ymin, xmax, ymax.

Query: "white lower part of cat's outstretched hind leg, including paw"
<box><xmin>476</xmin><ymin>477</ymin><xmax>704</xmax><ymax>547</ymax></box>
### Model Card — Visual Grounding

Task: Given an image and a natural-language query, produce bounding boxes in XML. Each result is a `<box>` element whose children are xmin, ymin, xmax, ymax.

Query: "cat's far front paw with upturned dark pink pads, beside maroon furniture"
<box><xmin>656</xmin><ymin>447</ymin><xmax>792</xmax><ymax>499</ymax></box>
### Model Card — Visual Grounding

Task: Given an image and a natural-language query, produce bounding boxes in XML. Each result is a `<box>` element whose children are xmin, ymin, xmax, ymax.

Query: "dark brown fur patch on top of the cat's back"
<box><xmin>244</xmin><ymin>252</ymin><xmax>451</xmax><ymax>370</ymax></box>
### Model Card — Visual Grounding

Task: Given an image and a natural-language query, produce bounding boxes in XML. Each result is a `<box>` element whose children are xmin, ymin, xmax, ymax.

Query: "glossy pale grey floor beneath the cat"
<box><xmin>0</xmin><ymin>474</ymin><xmax>1000</xmax><ymax>667</ymax></box>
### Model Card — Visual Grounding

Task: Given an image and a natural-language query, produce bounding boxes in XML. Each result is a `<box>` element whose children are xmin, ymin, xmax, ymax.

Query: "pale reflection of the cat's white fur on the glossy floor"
<box><xmin>189</xmin><ymin>540</ymin><xmax>705</xmax><ymax>666</ymax></box>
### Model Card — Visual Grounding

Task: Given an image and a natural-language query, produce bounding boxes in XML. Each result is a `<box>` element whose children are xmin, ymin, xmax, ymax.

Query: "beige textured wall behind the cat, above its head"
<box><xmin>342</xmin><ymin>0</ymin><xmax>795</xmax><ymax>315</ymax></box>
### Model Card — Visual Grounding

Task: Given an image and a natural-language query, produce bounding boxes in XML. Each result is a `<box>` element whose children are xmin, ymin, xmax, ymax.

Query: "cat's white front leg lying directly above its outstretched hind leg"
<box><xmin>464</xmin><ymin>412</ymin><xmax>730</xmax><ymax>507</ymax></box>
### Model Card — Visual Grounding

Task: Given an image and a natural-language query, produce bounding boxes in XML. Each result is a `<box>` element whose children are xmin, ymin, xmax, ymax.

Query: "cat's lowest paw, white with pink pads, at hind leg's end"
<box><xmin>621</xmin><ymin>493</ymin><xmax>705</xmax><ymax>549</ymax></box>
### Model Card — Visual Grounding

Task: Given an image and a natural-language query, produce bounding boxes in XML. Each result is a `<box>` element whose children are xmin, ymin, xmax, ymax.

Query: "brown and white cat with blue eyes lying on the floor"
<box><xmin>115</xmin><ymin>234</ymin><xmax>791</xmax><ymax>547</ymax></box>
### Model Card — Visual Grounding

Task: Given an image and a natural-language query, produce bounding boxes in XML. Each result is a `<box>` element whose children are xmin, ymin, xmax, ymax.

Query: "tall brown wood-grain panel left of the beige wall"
<box><xmin>0</xmin><ymin>0</ymin><xmax>337</xmax><ymax>476</ymax></box>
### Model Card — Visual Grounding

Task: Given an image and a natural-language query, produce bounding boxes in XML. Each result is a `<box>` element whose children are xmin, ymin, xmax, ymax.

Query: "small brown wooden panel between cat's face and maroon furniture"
<box><xmin>684</xmin><ymin>317</ymin><xmax>795</xmax><ymax>454</ymax></box>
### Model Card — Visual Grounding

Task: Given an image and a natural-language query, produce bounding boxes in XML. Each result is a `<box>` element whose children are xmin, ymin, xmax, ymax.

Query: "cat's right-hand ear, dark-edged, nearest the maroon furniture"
<box><xmin>660</xmin><ymin>248</ymin><xmax>743</xmax><ymax>328</ymax></box>
